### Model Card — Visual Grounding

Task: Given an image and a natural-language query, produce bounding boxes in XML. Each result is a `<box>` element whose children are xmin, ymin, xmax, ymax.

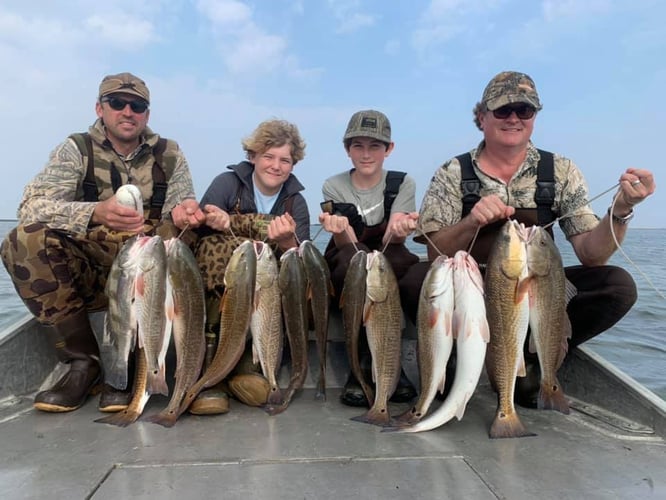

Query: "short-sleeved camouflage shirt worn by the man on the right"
<box><xmin>419</xmin><ymin>141</ymin><xmax>599</xmax><ymax>242</ymax></box>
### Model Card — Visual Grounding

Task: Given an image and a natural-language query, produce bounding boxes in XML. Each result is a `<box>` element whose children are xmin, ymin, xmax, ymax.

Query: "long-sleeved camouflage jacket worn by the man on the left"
<box><xmin>17</xmin><ymin>119</ymin><xmax>195</xmax><ymax>236</ymax></box>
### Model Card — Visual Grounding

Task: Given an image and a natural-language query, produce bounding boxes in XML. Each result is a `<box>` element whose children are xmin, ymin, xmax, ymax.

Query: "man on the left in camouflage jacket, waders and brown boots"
<box><xmin>2</xmin><ymin>73</ymin><xmax>205</xmax><ymax>412</ymax></box>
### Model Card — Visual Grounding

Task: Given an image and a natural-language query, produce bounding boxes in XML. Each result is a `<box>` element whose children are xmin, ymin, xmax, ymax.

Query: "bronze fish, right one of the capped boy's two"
<box><xmin>353</xmin><ymin>250</ymin><xmax>402</xmax><ymax>426</ymax></box>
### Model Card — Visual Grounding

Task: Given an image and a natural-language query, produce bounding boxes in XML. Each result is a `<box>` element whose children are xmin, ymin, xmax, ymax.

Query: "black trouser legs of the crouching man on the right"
<box><xmin>400</xmin><ymin>262</ymin><xmax>637</xmax><ymax>347</ymax></box>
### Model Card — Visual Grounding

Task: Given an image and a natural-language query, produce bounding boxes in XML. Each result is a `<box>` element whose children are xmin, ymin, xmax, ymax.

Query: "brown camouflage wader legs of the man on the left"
<box><xmin>0</xmin><ymin>222</ymin><xmax>196</xmax><ymax>325</ymax></box>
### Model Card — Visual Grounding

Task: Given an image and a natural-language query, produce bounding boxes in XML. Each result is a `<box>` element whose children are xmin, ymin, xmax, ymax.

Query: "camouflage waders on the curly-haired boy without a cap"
<box><xmin>194</xmin><ymin>214</ymin><xmax>278</xmax><ymax>293</ymax></box>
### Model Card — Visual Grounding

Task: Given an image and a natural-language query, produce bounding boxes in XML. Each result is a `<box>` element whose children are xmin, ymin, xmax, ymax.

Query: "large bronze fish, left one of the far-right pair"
<box><xmin>485</xmin><ymin>221</ymin><xmax>533</xmax><ymax>438</ymax></box>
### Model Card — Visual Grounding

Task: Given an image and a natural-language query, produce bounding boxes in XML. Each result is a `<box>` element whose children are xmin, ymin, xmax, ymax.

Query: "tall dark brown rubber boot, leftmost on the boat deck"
<box><xmin>34</xmin><ymin>309</ymin><xmax>102</xmax><ymax>413</ymax></box>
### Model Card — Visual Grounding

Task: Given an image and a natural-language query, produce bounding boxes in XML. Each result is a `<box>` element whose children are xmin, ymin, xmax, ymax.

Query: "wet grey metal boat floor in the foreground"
<box><xmin>0</xmin><ymin>382</ymin><xmax>666</xmax><ymax>500</ymax></box>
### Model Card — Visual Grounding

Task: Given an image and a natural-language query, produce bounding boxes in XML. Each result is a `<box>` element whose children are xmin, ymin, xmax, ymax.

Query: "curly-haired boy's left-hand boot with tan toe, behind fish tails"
<box><xmin>188</xmin><ymin>293</ymin><xmax>229</xmax><ymax>415</ymax></box>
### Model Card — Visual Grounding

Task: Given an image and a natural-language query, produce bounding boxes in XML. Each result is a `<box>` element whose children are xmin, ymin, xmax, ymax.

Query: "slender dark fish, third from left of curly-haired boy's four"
<box><xmin>264</xmin><ymin>248</ymin><xmax>308</xmax><ymax>415</ymax></box>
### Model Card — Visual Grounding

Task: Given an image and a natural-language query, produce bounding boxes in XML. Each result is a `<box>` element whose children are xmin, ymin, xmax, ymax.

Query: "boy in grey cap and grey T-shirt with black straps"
<box><xmin>319</xmin><ymin>109</ymin><xmax>418</xmax><ymax>406</ymax></box>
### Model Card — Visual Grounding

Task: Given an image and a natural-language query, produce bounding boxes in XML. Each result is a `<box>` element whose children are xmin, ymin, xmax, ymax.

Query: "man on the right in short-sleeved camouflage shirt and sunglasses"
<box><xmin>403</xmin><ymin>71</ymin><xmax>655</xmax><ymax>406</ymax></box>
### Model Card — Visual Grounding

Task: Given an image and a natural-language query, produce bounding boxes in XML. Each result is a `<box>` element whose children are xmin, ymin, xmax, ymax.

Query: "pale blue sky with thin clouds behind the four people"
<box><xmin>0</xmin><ymin>0</ymin><xmax>666</xmax><ymax>227</ymax></box>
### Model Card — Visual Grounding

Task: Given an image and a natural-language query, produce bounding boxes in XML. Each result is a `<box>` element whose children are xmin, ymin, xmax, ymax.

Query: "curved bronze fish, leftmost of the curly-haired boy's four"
<box><xmin>178</xmin><ymin>240</ymin><xmax>257</xmax><ymax>415</ymax></box>
